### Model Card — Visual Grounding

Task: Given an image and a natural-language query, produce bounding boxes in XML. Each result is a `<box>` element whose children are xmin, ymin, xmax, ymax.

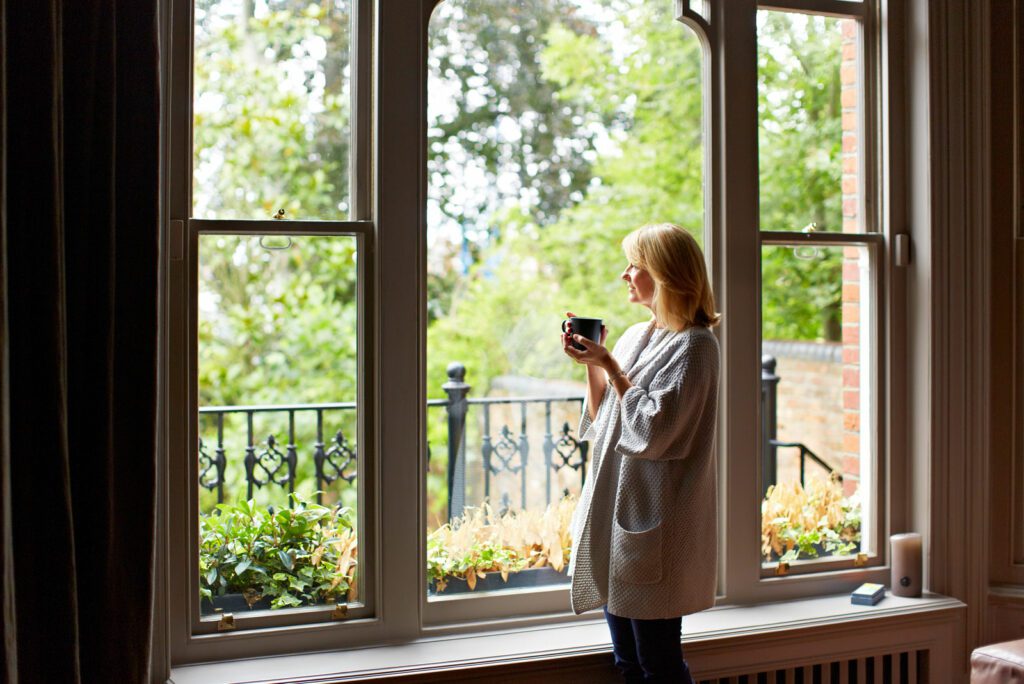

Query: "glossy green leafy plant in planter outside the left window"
<box><xmin>199</xmin><ymin>495</ymin><xmax>357</xmax><ymax>608</ymax></box>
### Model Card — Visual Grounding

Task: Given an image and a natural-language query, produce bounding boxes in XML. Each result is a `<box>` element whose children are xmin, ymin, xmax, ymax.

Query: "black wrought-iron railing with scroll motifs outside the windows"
<box><xmin>199</xmin><ymin>355</ymin><xmax>842</xmax><ymax>511</ymax></box>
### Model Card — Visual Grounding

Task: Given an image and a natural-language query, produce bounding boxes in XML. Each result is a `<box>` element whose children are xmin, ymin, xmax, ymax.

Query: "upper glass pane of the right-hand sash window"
<box><xmin>757</xmin><ymin>10</ymin><xmax>865</xmax><ymax>232</ymax></box>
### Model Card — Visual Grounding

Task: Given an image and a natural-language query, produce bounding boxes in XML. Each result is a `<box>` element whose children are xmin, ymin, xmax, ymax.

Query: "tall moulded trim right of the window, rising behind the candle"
<box><xmin>906</xmin><ymin>0</ymin><xmax>1006</xmax><ymax>656</ymax></box>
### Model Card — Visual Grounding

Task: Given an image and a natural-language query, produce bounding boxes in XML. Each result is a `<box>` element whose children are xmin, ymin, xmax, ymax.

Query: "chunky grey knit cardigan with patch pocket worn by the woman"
<box><xmin>569</xmin><ymin>324</ymin><xmax>719</xmax><ymax>619</ymax></box>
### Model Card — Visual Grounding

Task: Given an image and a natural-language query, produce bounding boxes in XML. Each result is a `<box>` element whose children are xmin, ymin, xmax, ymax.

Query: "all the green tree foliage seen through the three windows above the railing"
<box><xmin>194</xmin><ymin>0</ymin><xmax>842</xmax><ymax>511</ymax></box>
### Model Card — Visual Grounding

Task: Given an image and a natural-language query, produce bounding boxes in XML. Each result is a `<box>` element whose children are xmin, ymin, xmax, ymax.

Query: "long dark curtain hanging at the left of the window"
<box><xmin>0</xmin><ymin>0</ymin><xmax>160</xmax><ymax>683</ymax></box>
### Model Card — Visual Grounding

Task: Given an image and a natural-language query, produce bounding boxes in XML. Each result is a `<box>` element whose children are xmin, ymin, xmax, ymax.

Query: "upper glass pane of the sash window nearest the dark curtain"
<box><xmin>193</xmin><ymin>0</ymin><xmax>351</xmax><ymax>219</ymax></box>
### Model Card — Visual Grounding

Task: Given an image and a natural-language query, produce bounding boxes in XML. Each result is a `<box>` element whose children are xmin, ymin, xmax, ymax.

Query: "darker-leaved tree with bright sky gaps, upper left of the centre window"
<box><xmin>427</xmin><ymin>0</ymin><xmax>597</xmax><ymax>319</ymax></box>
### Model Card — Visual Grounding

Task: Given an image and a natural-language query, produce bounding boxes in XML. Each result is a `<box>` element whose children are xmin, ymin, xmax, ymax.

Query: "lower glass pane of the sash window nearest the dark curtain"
<box><xmin>198</xmin><ymin>236</ymin><xmax>358</xmax><ymax>614</ymax></box>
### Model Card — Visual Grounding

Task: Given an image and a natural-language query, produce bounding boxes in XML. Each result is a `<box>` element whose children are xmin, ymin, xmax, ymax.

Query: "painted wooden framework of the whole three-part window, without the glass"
<box><xmin>163</xmin><ymin>0</ymin><xmax>908</xmax><ymax>665</ymax></box>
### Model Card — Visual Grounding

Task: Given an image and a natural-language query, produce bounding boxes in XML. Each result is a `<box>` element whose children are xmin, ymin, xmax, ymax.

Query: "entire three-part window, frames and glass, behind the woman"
<box><xmin>168</xmin><ymin>0</ymin><xmax>898</xmax><ymax>662</ymax></box>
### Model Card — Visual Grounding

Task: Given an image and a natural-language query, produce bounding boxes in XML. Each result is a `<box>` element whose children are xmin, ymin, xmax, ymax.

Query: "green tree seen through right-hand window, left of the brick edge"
<box><xmin>758</xmin><ymin>11</ymin><xmax>843</xmax><ymax>341</ymax></box>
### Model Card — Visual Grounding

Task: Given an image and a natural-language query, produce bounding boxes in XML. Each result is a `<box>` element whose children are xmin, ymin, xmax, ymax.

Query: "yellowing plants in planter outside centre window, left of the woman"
<box><xmin>427</xmin><ymin>497</ymin><xmax>577</xmax><ymax>593</ymax></box>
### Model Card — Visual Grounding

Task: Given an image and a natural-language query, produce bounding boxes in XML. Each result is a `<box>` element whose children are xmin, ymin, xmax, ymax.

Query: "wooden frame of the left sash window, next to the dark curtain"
<box><xmin>165</xmin><ymin>0</ymin><xmax>380</xmax><ymax>662</ymax></box>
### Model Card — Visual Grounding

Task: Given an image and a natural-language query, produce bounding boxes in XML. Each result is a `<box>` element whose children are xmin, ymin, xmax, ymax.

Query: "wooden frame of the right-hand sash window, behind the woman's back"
<box><xmin>713</xmin><ymin>0</ymin><xmax>906</xmax><ymax>603</ymax></box>
